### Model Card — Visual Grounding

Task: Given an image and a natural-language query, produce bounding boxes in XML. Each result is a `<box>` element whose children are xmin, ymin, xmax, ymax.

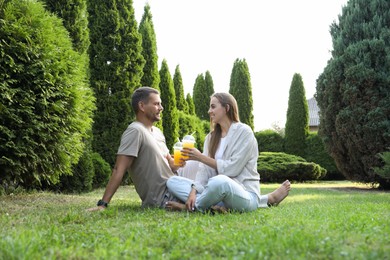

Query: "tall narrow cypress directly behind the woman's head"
<box><xmin>229</xmin><ymin>59</ymin><xmax>254</xmax><ymax>130</ymax></box>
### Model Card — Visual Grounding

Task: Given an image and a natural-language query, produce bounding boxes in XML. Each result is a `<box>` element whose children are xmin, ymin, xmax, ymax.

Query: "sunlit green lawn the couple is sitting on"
<box><xmin>0</xmin><ymin>182</ymin><xmax>390</xmax><ymax>259</ymax></box>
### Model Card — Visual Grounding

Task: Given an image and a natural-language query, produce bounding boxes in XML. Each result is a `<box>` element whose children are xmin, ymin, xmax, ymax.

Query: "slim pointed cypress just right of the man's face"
<box><xmin>160</xmin><ymin>59</ymin><xmax>179</xmax><ymax>149</ymax></box>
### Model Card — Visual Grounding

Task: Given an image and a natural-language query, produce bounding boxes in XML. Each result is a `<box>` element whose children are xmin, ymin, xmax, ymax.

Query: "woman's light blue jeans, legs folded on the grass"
<box><xmin>167</xmin><ymin>175</ymin><xmax>268</xmax><ymax>212</ymax></box>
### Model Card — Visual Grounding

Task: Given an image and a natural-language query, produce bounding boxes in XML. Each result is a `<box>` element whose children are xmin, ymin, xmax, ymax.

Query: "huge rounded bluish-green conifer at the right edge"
<box><xmin>316</xmin><ymin>0</ymin><xmax>390</xmax><ymax>188</ymax></box>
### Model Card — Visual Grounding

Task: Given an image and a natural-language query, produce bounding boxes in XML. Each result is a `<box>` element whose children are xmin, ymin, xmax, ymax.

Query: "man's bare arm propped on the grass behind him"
<box><xmin>88</xmin><ymin>155</ymin><xmax>134</xmax><ymax>211</ymax></box>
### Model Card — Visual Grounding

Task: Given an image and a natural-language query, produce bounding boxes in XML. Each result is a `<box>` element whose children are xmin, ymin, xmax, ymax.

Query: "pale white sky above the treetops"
<box><xmin>133</xmin><ymin>0</ymin><xmax>348</xmax><ymax>131</ymax></box>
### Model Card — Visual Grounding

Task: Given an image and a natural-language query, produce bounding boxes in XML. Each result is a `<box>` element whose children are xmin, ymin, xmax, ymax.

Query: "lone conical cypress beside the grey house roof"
<box><xmin>284</xmin><ymin>73</ymin><xmax>309</xmax><ymax>156</ymax></box>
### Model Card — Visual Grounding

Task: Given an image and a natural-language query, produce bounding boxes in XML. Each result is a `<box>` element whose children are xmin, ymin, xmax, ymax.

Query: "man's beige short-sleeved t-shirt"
<box><xmin>118</xmin><ymin>122</ymin><xmax>174</xmax><ymax>207</ymax></box>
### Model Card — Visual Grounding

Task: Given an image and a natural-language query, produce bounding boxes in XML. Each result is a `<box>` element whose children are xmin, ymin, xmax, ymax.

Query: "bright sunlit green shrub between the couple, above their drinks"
<box><xmin>178</xmin><ymin>111</ymin><xmax>210</xmax><ymax>151</ymax></box>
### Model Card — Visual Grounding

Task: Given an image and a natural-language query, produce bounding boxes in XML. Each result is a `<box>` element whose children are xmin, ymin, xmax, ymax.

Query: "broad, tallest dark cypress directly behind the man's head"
<box><xmin>88</xmin><ymin>0</ymin><xmax>145</xmax><ymax>166</ymax></box>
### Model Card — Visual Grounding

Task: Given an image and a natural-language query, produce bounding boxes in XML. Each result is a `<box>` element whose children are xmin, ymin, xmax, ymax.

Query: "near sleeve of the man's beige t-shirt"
<box><xmin>117</xmin><ymin>127</ymin><xmax>142</xmax><ymax>157</ymax></box>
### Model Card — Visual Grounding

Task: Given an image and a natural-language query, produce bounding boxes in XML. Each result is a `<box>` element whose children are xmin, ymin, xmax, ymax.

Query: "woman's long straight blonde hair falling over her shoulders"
<box><xmin>209</xmin><ymin>92</ymin><xmax>240</xmax><ymax>159</ymax></box>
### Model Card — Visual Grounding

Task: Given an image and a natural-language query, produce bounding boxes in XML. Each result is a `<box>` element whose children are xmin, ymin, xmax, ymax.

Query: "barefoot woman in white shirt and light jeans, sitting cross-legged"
<box><xmin>166</xmin><ymin>93</ymin><xmax>290</xmax><ymax>212</ymax></box>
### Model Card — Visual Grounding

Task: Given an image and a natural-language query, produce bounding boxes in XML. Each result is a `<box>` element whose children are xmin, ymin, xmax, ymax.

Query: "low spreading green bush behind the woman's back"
<box><xmin>257</xmin><ymin>152</ymin><xmax>326</xmax><ymax>182</ymax></box>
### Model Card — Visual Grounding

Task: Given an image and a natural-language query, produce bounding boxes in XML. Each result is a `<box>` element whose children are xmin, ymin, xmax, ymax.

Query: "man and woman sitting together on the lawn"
<box><xmin>88</xmin><ymin>87</ymin><xmax>290</xmax><ymax>212</ymax></box>
